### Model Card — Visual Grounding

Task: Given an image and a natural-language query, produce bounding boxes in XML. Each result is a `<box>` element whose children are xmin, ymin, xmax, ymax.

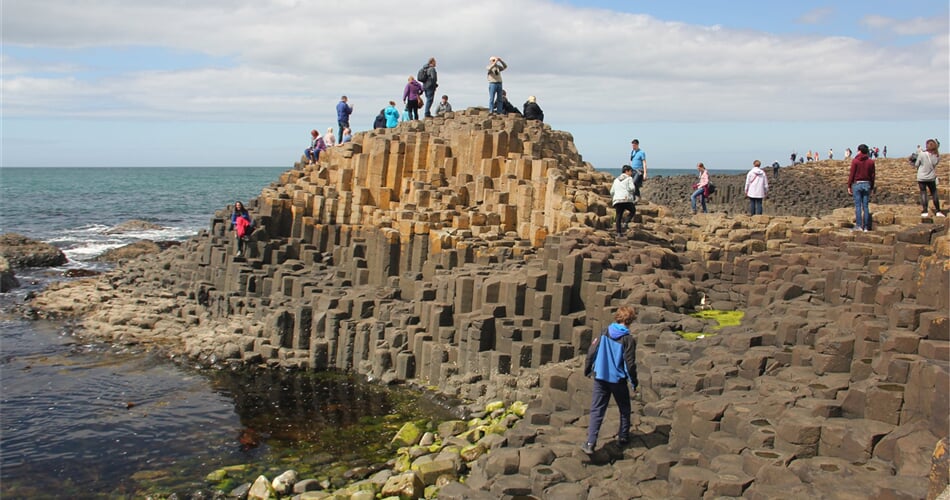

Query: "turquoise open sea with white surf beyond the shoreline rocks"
<box><xmin>0</xmin><ymin>167</ymin><xmax>287</xmax><ymax>267</ymax></box>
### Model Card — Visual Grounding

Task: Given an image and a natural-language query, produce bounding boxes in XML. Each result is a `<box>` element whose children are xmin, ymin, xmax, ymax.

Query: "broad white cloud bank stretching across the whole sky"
<box><xmin>2</xmin><ymin>0</ymin><xmax>950</xmax><ymax>160</ymax></box>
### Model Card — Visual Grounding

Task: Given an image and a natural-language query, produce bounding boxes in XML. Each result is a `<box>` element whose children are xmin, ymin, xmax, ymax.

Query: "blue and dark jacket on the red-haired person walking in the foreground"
<box><xmin>584</xmin><ymin>323</ymin><xmax>637</xmax><ymax>387</ymax></box>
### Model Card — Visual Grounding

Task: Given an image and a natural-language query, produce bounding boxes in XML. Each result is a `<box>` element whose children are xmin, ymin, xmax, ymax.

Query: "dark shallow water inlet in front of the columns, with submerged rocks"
<box><xmin>0</xmin><ymin>280</ymin><xmax>451</xmax><ymax>499</ymax></box>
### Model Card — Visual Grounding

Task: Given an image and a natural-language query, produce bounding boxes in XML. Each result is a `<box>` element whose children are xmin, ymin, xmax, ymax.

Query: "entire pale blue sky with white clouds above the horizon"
<box><xmin>0</xmin><ymin>0</ymin><xmax>950</xmax><ymax>171</ymax></box>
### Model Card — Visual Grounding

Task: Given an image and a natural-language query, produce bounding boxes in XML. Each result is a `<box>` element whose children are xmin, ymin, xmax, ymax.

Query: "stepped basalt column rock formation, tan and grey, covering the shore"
<box><xmin>33</xmin><ymin>109</ymin><xmax>950</xmax><ymax>499</ymax></box>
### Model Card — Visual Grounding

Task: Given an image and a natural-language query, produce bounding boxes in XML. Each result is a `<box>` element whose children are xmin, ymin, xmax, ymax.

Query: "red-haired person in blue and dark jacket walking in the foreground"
<box><xmin>581</xmin><ymin>306</ymin><xmax>637</xmax><ymax>455</ymax></box>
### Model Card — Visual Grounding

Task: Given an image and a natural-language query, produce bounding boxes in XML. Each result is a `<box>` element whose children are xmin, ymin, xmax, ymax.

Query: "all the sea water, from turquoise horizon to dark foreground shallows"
<box><xmin>0</xmin><ymin>167</ymin><xmax>462</xmax><ymax>500</ymax></box>
